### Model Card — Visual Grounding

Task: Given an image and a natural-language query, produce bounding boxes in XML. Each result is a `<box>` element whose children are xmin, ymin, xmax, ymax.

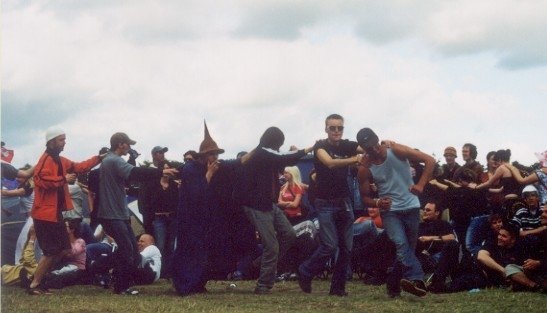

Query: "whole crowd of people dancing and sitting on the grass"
<box><xmin>2</xmin><ymin>114</ymin><xmax>547</xmax><ymax>297</ymax></box>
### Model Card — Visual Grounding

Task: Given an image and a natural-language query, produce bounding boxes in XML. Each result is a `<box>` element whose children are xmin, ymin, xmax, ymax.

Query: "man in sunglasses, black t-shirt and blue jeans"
<box><xmin>298</xmin><ymin>114</ymin><xmax>362</xmax><ymax>296</ymax></box>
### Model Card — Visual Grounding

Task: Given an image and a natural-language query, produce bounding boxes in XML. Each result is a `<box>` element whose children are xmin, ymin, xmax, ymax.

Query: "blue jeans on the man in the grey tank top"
<box><xmin>381</xmin><ymin>208</ymin><xmax>424</xmax><ymax>280</ymax></box>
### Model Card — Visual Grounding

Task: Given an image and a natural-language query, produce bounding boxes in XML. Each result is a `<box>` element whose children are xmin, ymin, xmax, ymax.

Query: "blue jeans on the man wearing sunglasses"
<box><xmin>299</xmin><ymin>198</ymin><xmax>353</xmax><ymax>292</ymax></box>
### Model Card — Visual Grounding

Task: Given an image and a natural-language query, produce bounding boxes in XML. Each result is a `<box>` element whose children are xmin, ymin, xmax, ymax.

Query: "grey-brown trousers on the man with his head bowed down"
<box><xmin>243</xmin><ymin>204</ymin><xmax>296</xmax><ymax>288</ymax></box>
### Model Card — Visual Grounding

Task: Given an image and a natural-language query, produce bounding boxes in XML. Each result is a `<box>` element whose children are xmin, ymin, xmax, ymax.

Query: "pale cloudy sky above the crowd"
<box><xmin>1</xmin><ymin>0</ymin><xmax>547</xmax><ymax>166</ymax></box>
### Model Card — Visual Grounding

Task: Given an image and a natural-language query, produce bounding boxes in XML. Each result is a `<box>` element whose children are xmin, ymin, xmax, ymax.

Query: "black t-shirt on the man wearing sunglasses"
<box><xmin>313</xmin><ymin>139</ymin><xmax>357</xmax><ymax>200</ymax></box>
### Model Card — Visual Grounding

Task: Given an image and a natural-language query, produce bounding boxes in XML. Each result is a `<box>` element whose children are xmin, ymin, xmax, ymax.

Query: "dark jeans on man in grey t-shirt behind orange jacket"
<box><xmin>101</xmin><ymin>219</ymin><xmax>140</xmax><ymax>293</ymax></box>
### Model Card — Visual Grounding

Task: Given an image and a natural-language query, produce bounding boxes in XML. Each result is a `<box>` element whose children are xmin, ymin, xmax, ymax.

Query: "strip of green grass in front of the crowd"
<box><xmin>2</xmin><ymin>280</ymin><xmax>547</xmax><ymax>313</ymax></box>
